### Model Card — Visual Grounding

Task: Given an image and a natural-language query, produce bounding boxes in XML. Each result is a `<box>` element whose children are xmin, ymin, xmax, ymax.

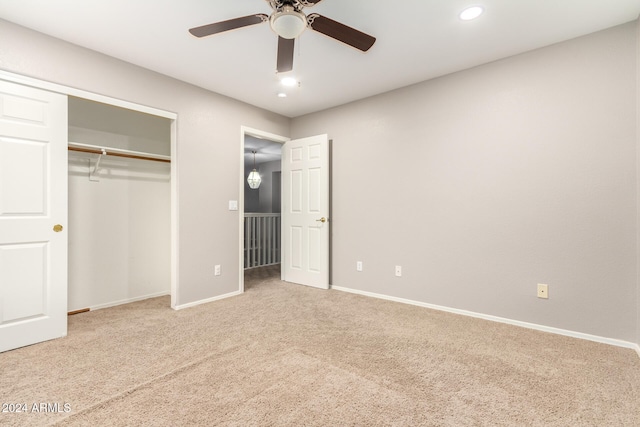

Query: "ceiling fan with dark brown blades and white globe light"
<box><xmin>189</xmin><ymin>0</ymin><xmax>376</xmax><ymax>73</ymax></box>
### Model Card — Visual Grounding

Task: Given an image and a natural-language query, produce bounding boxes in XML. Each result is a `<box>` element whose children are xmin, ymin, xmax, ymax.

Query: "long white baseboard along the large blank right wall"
<box><xmin>331</xmin><ymin>286</ymin><xmax>640</xmax><ymax>357</ymax></box>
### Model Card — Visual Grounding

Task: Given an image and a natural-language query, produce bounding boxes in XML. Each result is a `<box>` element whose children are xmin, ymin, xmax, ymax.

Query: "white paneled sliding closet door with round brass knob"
<box><xmin>0</xmin><ymin>81</ymin><xmax>67</xmax><ymax>351</ymax></box>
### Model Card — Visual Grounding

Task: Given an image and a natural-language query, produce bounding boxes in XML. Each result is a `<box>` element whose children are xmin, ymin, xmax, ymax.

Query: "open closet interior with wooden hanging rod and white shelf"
<box><xmin>67</xmin><ymin>96</ymin><xmax>171</xmax><ymax>312</ymax></box>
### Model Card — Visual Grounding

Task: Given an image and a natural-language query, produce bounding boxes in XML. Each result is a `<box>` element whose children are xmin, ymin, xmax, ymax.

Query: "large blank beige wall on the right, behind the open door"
<box><xmin>291</xmin><ymin>23</ymin><xmax>638</xmax><ymax>342</ymax></box>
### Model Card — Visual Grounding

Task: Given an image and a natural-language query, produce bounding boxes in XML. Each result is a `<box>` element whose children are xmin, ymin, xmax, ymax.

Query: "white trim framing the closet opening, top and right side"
<box><xmin>0</xmin><ymin>70</ymin><xmax>179</xmax><ymax>309</ymax></box>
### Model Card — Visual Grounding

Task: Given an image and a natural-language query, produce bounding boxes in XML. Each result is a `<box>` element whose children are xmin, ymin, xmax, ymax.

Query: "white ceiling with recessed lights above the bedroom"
<box><xmin>0</xmin><ymin>0</ymin><xmax>640</xmax><ymax>117</ymax></box>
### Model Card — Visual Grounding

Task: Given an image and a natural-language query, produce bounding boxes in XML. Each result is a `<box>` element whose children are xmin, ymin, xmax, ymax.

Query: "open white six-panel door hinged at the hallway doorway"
<box><xmin>281</xmin><ymin>135</ymin><xmax>330</xmax><ymax>289</ymax></box>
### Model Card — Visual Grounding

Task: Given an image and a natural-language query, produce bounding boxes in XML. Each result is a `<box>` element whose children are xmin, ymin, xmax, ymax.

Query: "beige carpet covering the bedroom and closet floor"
<box><xmin>0</xmin><ymin>268</ymin><xmax>640</xmax><ymax>426</ymax></box>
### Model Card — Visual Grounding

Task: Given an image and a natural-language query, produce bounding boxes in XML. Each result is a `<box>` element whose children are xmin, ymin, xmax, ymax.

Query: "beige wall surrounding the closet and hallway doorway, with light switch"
<box><xmin>0</xmin><ymin>20</ymin><xmax>290</xmax><ymax>305</ymax></box>
